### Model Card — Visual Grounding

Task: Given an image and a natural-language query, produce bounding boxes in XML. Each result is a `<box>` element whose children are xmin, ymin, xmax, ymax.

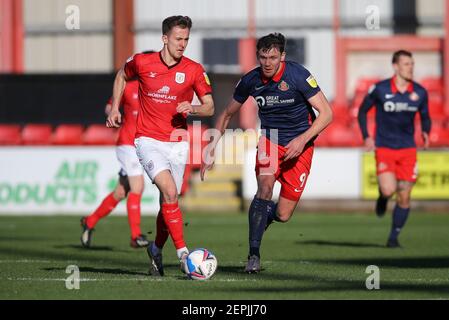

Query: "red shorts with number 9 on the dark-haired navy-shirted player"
<box><xmin>256</xmin><ymin>137</ymin><xmax>314</xmax><ymax>201</ymax></box>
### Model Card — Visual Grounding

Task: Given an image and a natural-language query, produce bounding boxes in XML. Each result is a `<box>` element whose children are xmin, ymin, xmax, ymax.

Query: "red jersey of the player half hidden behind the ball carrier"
<box><xmin>109</xmin><ymin>80</ymin><xmax>140</xmax><ymax>146</ymax></box>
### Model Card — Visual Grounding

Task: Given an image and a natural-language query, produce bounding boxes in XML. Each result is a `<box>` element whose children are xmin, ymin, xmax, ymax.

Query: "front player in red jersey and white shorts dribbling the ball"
<box><xmin>107</xmin><ymin>16</ymin><xmax>214</xmax><ymax>276</ymax></box>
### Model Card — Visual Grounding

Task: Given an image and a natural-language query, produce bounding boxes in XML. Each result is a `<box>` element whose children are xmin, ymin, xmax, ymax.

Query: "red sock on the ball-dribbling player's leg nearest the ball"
<box><xmin>160</xmin><ymin>202</ymin><xmax>186</xmax><ymax>249</ymax></box>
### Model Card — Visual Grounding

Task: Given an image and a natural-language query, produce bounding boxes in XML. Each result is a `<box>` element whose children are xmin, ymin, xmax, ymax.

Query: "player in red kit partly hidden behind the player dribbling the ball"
<box><xmin>81</xmin><ymin>77</ymin><xmax>148</xmax><ymax>248</ymax></box>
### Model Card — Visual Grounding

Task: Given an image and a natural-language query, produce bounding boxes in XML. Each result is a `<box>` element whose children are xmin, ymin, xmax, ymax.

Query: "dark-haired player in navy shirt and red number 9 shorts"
<box><xmin>201</xmin><ymin>33</ymin><xmax>332</xmax><ymax>273</ymax></box>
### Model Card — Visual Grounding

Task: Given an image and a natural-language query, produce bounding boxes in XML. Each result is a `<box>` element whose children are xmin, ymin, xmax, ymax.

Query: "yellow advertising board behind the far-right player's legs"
<box><xmin>361</xmin><ymin>151</ymin><xmax>449</xmax><ymax>200</ymax></box>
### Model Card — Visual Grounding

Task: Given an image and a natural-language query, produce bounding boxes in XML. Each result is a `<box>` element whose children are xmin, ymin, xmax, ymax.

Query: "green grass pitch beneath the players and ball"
<box><xmin>0</xmin><ymin>212</ymin><xmax>449</xmax><ymax>300</ymax></box>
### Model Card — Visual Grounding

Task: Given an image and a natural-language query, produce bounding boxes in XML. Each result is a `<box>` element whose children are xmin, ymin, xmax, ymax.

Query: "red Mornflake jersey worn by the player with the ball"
<box><xmin>124</xmin><ymin>52</ymin><xmax>212</xmax><ymax>141</ymax></box>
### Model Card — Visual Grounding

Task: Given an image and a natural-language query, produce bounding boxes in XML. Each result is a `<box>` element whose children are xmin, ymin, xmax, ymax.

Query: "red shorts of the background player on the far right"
<box><xmin>376</xmin><ymin>148</ymin><xmax>418</xmax><ymax>182</ymax></box>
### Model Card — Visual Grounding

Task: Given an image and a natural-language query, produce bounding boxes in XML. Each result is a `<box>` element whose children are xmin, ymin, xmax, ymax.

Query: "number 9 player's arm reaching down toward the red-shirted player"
<box><xmin>200</xmin><ymin>99</ymin><xmax>242</xmax><ymax>180</ymax></box>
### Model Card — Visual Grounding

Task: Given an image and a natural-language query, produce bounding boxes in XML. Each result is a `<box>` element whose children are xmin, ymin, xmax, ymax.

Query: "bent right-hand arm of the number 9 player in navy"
<box><xmin>284</xmin><ymin>91</ymin><xmax>333</xmax><ymax>160</ymax></box>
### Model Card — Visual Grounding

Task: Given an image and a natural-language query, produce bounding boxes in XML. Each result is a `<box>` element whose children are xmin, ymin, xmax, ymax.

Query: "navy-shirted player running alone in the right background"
<box><xmin>358</xmin><ymin>50</ymin><xmax>431</xmax><ymax>248</ymax></box>
